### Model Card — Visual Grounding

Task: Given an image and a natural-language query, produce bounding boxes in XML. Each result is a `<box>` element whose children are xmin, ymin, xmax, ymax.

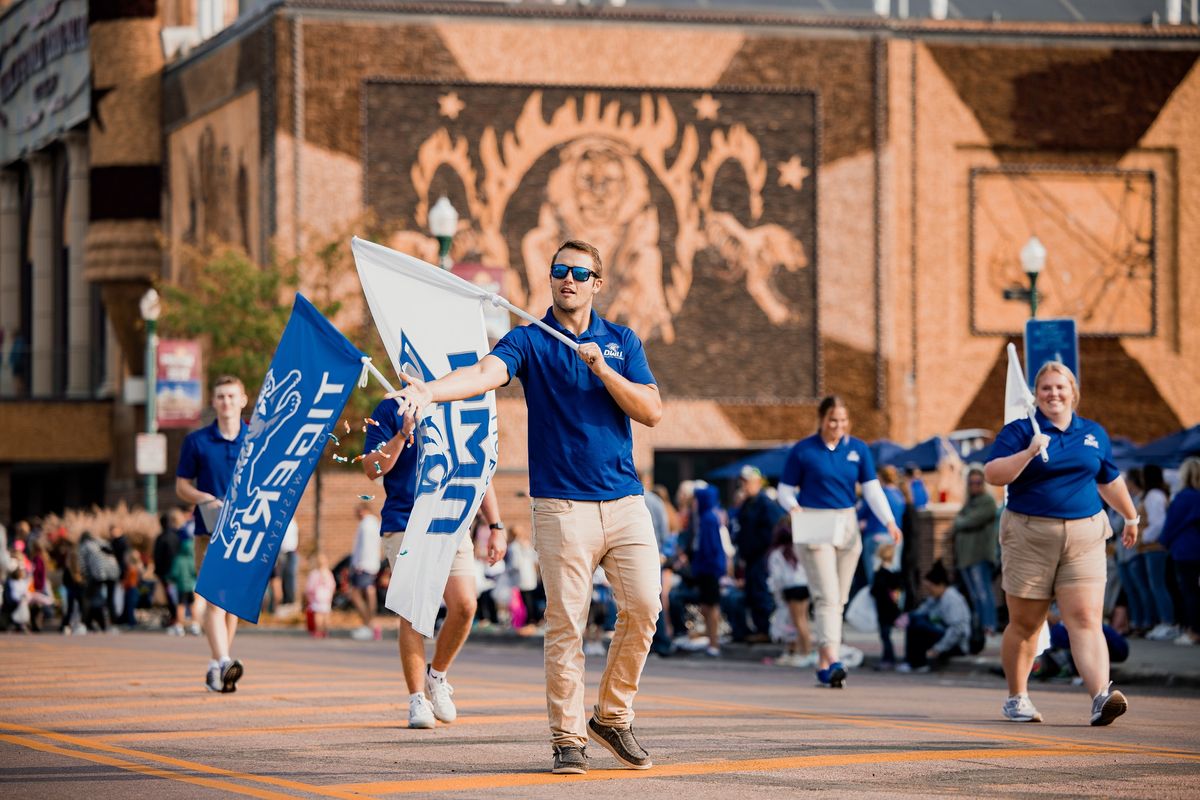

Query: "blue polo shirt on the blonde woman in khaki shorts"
<box><xmin>988</xmin><ymin>410</ymin><xmax>1121</xmax><ymax>519</ymax></box>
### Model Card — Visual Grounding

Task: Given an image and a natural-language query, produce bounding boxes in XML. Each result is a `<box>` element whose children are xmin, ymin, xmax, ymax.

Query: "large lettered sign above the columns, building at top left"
<box><xmin>0</xmin><ymin>0</ymin><xmax>91</xmax><ymax>166</ymax></box>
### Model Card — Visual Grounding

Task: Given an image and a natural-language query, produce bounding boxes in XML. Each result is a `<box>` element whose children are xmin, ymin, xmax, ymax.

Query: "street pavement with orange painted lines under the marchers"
<box><xmin>0</xmin><ymin>631</ymin><xmax>1200</xmax><ymax>800</ymax></box>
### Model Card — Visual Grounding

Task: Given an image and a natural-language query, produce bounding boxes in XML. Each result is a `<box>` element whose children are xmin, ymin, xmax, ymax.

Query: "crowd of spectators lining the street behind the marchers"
<box><xmin>0</xmin><ymin>458</ymin><xmax>1200</xmax><ymax>678</ymax></box>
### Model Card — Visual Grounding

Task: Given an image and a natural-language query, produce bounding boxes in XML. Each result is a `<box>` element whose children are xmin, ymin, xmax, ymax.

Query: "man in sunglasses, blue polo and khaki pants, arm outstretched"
<box><xmin>386</xmin><ymin>240</ymin><xmax>662</xmax><ymax>774</ymax></box>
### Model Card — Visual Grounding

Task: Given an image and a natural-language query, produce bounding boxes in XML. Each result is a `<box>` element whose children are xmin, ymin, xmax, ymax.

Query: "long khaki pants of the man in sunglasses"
<box><xmin>532</xmin><ymin>495</ymin><xmax>662</xmax><ymax>747</ymax></box>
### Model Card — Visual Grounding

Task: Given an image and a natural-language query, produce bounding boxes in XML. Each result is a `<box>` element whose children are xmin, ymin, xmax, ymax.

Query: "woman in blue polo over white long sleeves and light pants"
<box><xmin>779</xmin><ymin>397</ymin><xmax>900</xmax><ymax>688</ymax></box>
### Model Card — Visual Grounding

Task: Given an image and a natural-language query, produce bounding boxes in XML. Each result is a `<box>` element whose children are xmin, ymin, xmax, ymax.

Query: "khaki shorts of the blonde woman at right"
<box><xmin>1000</xmin><ymin>511</ymin><xmax>1112</xmax><ymax>600</ymax></box>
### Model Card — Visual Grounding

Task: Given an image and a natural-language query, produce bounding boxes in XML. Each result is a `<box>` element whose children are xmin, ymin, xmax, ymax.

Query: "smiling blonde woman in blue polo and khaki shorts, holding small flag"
<box><xmin>984</xmin><ymin>361</ymin><xmax>1140</xmax><ymax>726</ymax></box>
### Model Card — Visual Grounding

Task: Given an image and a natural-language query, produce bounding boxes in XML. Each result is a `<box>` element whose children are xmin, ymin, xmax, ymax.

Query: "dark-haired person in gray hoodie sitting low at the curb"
<box><xmin>896</xmin><ymin>561</ymin><xmax>971</xmax><ymax>672</ymax></box>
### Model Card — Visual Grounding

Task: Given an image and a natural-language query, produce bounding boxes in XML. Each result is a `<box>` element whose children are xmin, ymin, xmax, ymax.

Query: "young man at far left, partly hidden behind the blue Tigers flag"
<box><xmin>175</xmin><ymin>375</ymin><xmax>247</xmax><ymax>693</ymax></box>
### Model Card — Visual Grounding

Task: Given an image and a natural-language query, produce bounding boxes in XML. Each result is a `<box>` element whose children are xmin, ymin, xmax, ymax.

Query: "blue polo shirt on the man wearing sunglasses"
<box><xmin>492</xmin><ymin>311</ymin><xmax>658</xmax><ymax>500</ymax></box>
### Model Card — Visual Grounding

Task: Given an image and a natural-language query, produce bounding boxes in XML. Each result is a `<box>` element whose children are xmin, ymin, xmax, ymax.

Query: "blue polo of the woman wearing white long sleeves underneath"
<box><xmin>780</xmin><ymin>433</ymin><xmax>875</xmax><ymax>509</ymax></box>
